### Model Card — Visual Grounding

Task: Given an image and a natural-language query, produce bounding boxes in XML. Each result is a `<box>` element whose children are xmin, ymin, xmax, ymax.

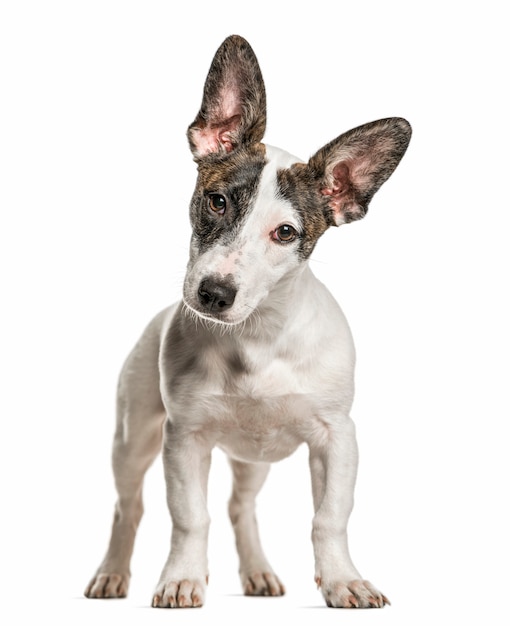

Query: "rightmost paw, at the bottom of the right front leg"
<box><xmin>316</xmin><ymin>578</ymin><xmax>390</xmax><ymax>609</ymax></box>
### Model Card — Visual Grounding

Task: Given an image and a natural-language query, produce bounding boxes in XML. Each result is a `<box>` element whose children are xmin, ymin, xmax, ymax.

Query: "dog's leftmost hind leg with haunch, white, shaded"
<box><xmin>85</xmin><ymin>312</ymin><xmax>165</xmax><ymax>598</ymax></box>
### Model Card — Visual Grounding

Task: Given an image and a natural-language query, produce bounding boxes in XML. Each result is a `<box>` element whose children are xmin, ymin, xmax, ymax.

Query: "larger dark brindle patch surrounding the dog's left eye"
<box><xmin>190</xmin><ymin>144</ymin><xmax>266</xmax><ymax>252</ymax></box>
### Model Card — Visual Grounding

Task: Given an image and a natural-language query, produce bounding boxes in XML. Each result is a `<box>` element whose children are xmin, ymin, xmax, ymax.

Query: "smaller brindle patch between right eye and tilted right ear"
<box><xmin>277</xmin><ymin>163</ymin><xmax>333</xmax><ymax>259</ymax></box>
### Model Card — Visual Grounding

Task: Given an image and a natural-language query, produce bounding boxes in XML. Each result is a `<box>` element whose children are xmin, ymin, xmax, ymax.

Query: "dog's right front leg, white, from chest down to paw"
<box><xmin>310</xmin><ymin>416</ymin><xmax>388</xmax><ymax>608</ymax></box>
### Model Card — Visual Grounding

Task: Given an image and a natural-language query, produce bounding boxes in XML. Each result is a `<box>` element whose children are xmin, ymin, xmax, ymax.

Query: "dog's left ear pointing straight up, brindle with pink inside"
<box><xmin>188</xmin><ymin>35</ymin><xmax>266</xmax><ymax>158</ymax></box>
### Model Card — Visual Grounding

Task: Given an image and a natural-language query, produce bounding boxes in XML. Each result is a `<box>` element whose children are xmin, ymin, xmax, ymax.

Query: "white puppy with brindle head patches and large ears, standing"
<box><xmin>85</xmin><ymin>35</ymin><xmax>411</xmax><ymax>608</ymax></box>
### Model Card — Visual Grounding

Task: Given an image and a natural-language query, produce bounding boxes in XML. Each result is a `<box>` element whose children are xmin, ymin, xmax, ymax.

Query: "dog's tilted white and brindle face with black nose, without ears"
<box><xmin>184</xmin><ymin>143</ymin><xmax>327</xmax><ymax>324</ymax></box>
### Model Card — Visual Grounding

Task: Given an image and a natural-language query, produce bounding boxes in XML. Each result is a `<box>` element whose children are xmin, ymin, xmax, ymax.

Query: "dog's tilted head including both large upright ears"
<box><xmin>184</xmin><ymin>36</ymin><xmax>411</xmax><ymax>324</ymax></box>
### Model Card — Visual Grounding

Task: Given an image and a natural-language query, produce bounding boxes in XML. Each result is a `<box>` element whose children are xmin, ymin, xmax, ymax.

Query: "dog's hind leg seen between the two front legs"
<box><xmin>229</xmin><ymin>460</ymin><xmax>285</xmax><ymax>596</ymax></box>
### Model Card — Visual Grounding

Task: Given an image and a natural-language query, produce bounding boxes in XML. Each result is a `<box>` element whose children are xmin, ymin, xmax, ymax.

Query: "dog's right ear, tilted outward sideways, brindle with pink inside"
<box><xmin>308</xmin><ymin>117</ymin><xmax>411</xmax><ymax>226</ymax></box>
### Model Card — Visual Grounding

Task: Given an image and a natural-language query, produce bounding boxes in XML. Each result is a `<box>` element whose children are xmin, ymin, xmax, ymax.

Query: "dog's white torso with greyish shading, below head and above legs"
<box><xmin>151</xmin><ymin>265</ymin><xmax>354</xmax><ymax>462</ymax></box>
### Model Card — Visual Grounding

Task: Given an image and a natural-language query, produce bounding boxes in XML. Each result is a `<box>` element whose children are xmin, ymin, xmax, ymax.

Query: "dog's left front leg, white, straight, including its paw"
<box><xmin>152</xmin><ymin>419</ymin><xmax>212</xmax><ymax>608</ymax></box>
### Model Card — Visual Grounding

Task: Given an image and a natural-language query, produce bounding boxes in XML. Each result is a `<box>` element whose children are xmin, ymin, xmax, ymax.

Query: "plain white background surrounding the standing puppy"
<box><xmin>0</xmin><ymin>0</ymin><xmax>510</xmax><ymax>625</ymax></box>
